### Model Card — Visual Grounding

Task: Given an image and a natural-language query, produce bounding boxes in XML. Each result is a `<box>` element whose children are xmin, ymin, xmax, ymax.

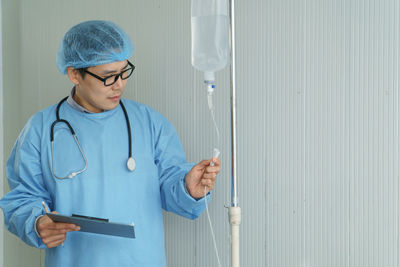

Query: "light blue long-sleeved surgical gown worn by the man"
<box><xmin>0</xmin><ymin>100</ymin><xmax>209</xmax><ymax>267</ymax></box>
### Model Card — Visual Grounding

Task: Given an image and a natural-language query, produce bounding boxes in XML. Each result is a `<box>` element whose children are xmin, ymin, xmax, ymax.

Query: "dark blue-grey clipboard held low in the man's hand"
<box><xmin>46</xmin><ymin>213</ymin><xmax>135</xmax><ymax>238</ymax></box>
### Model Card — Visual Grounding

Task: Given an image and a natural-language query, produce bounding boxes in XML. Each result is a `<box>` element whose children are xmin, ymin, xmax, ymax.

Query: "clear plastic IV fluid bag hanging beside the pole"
<box><xmin>192</xmin><ymin>0</ymin><xmax>229</xmax><ymax>79</ymax></box>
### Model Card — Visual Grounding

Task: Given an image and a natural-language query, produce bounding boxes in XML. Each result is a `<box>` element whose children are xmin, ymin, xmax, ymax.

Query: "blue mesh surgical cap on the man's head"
<box><xmin>57</xmin><ymin>20</ymin><xmax>134</xmax><ymax>74</ymax></box>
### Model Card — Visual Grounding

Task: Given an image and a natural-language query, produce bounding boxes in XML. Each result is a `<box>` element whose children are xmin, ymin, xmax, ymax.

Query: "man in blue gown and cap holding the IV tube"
<box><xmin>0</xmin><ymin>21</ymin><xmax>220</xmax><ymax>267</ymax></box>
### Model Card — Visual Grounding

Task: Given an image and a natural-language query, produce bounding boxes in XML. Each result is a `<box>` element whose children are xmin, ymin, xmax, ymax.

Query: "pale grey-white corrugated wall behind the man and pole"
<box><xmin>3</xmin><ymin>0</ymin><xmax>400</xmax><ymax>267</ymax></box>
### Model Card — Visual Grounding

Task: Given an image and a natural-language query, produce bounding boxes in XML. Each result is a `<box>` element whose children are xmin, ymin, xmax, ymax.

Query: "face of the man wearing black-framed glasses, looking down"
<box><xmin>74</xmin><ymin>60</ymin><xmax>129</xmax><ymax>113</ymax></box>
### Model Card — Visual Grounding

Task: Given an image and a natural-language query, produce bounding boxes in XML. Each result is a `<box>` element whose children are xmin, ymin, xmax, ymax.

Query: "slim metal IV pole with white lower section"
<box><xmin>229</xmin><ymin>0</ymin><xmax>241</xmax><ymax>267</ymax></box>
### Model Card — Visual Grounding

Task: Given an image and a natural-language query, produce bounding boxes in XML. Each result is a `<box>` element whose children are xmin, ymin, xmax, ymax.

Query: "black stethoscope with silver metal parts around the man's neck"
<box><xmin>50</xmin><ymin>96</ymin><xmax>136</xmax><ymax>179</ymax></box>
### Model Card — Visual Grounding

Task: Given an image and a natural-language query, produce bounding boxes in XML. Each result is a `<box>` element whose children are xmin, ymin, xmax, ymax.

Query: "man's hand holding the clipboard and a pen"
<box><xmin>36</xmin><ymin>214</ymin><xmax>81</xmax><ymax>248</ymax></box>
